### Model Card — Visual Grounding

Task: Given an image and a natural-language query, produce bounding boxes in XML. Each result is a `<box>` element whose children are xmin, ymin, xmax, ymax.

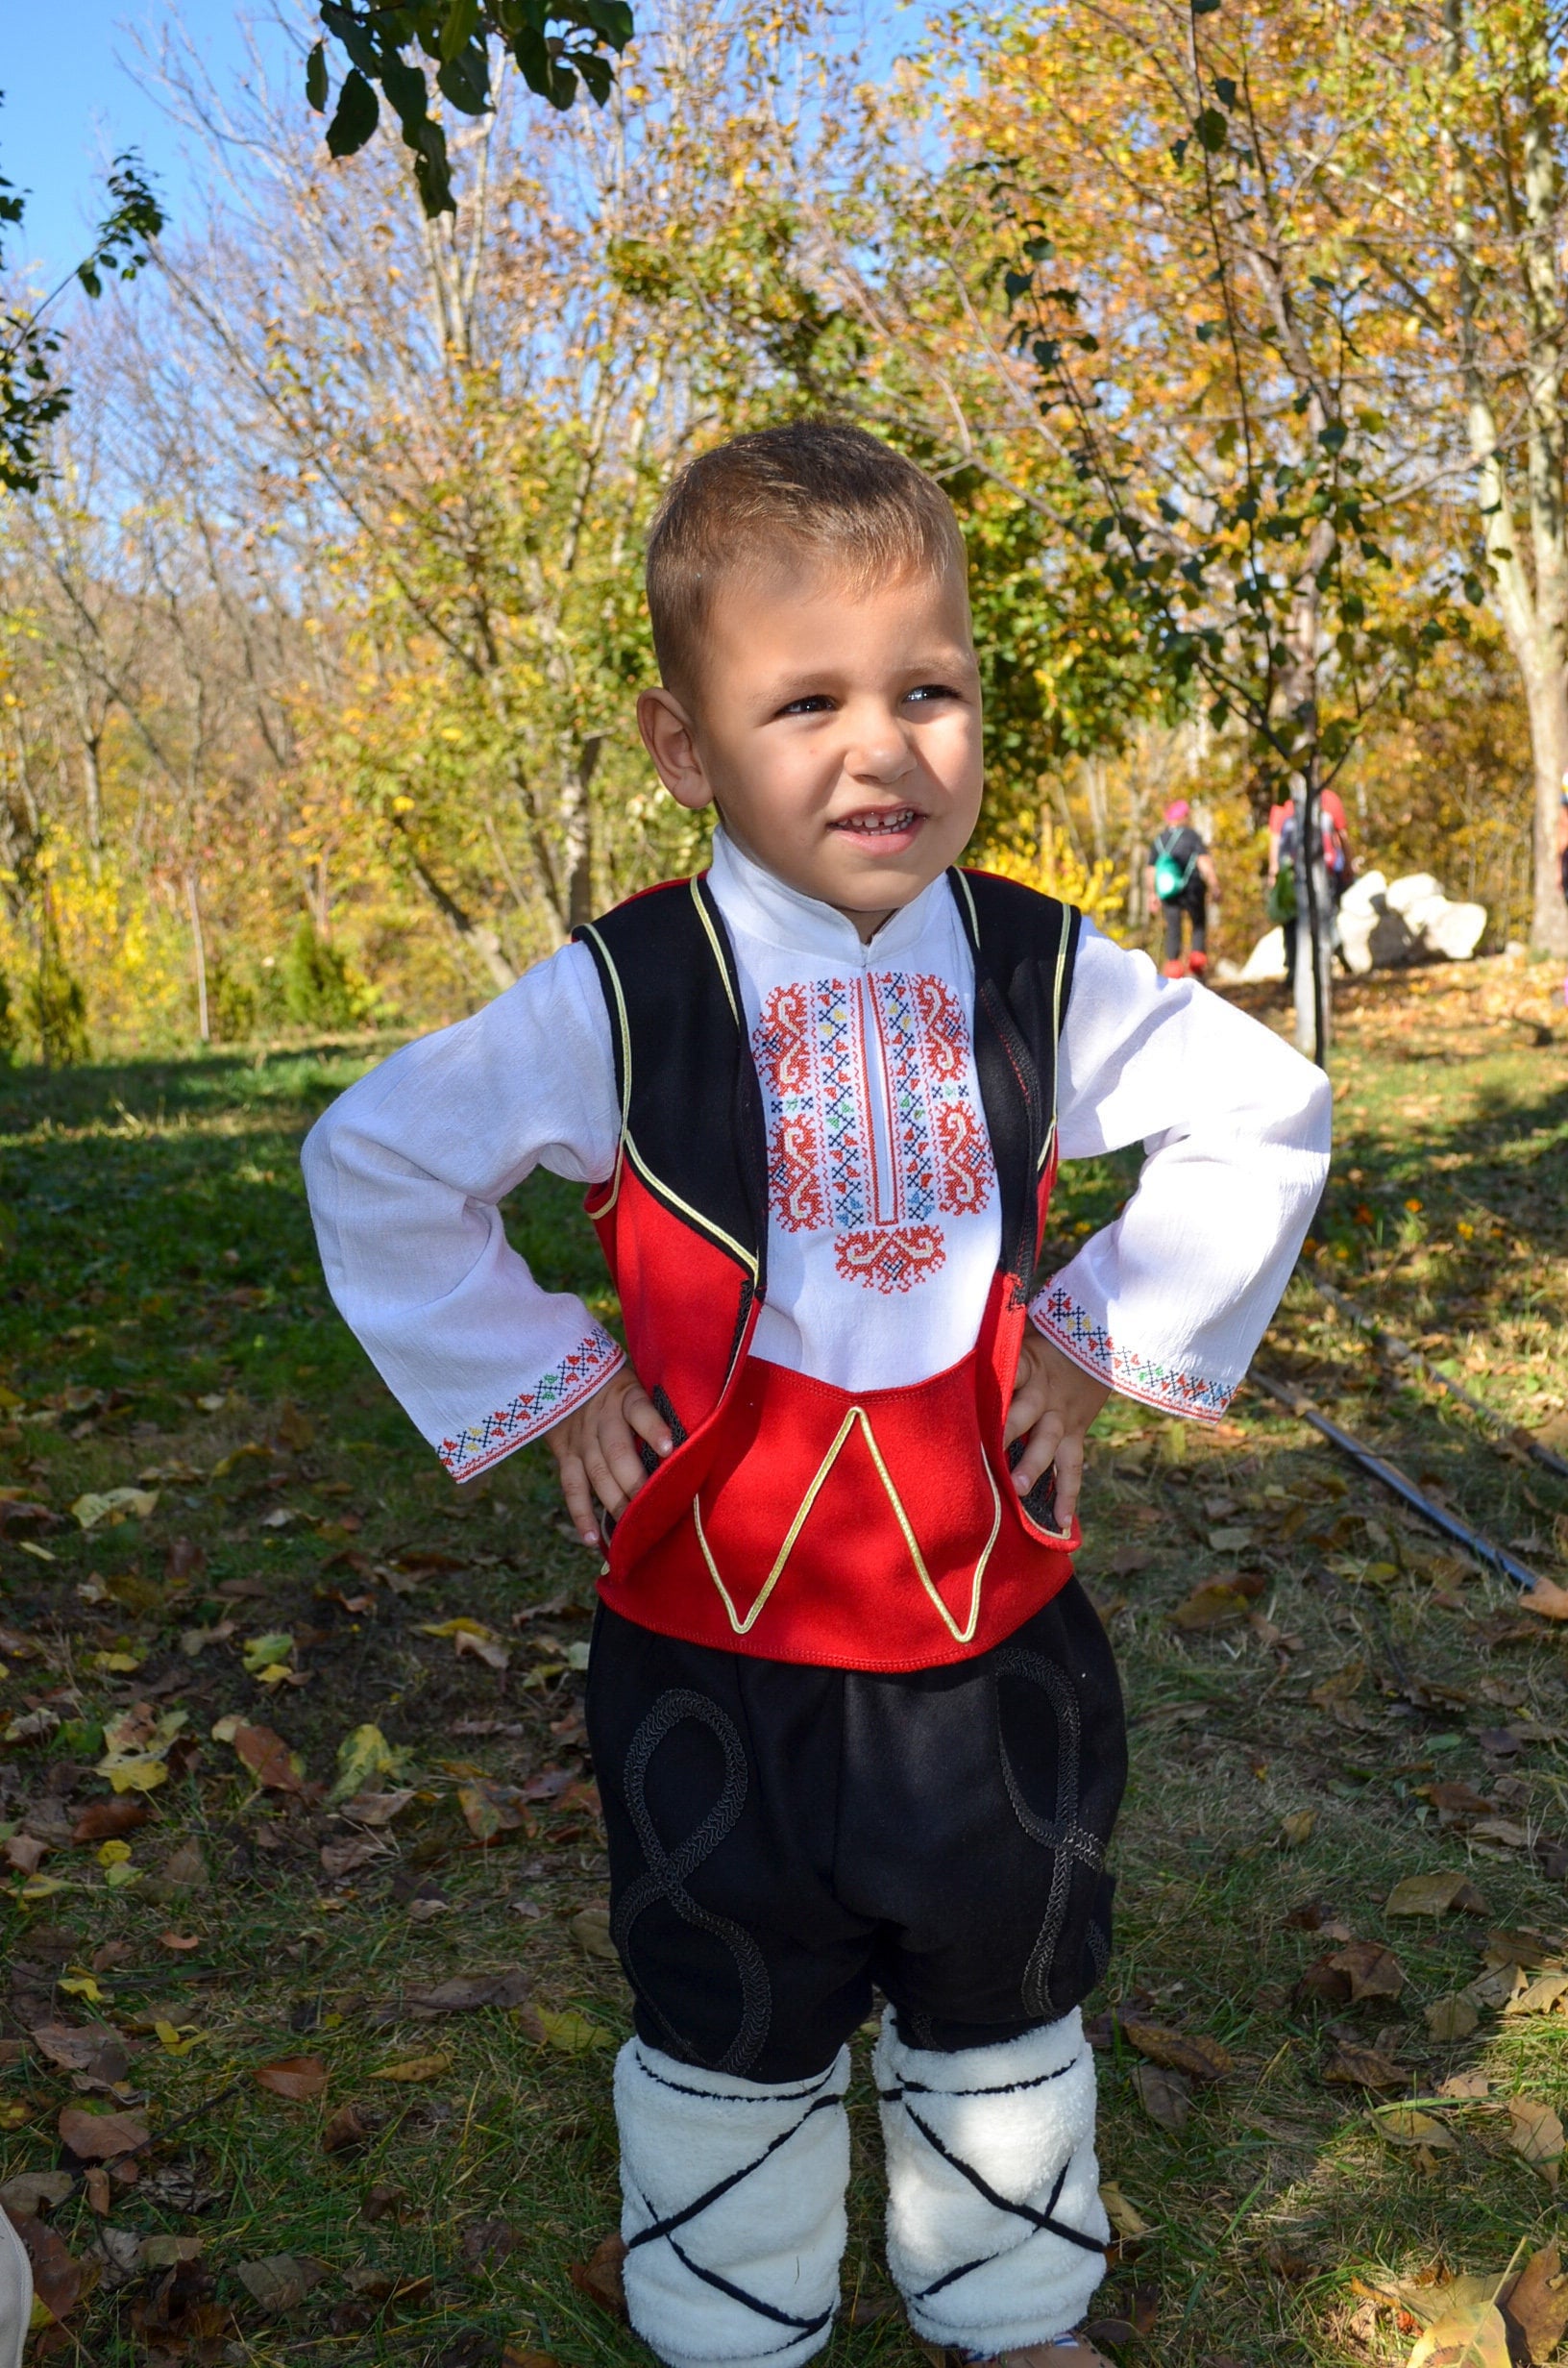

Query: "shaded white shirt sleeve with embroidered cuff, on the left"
<box><xmin>301</xmin><ymin>945</ymin><xmax>623</xmax><ymax>1480</ymax></box>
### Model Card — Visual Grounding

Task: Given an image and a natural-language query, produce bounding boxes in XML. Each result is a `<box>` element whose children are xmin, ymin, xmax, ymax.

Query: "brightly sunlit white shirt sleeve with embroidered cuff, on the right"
<box><xmin>1030</xmin><ymin>921</ymin><xmax>1331</xmax><ymax>1420</ymax></box>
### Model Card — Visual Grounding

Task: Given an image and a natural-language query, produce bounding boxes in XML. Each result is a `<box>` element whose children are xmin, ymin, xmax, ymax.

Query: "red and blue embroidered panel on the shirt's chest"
<box><xmin>750</xmin><ymin>971</ymin><xmax>994</xmax><ymax>1293</ymax></box>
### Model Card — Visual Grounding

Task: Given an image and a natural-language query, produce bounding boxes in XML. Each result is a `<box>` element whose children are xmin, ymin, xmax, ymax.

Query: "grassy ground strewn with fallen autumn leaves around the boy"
<box><xmin>0</xmin><ymin>961</ymin><xmax>1568</xmax><ymax>2368</ymax></box>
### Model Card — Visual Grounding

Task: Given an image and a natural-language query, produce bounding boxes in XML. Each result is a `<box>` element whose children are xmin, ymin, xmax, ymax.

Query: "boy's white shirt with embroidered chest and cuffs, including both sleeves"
<box><xmin>304</xmin><ymin>831</ymin><xmax>1329</xmax><ymax>1480</ymax></box>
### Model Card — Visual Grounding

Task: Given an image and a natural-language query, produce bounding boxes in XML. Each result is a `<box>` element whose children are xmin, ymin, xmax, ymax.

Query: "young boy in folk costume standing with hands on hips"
<box><xmin>306</xmin><ymin>424</ymin><xmax>1329</xmax><ymax>2368</ymax></box>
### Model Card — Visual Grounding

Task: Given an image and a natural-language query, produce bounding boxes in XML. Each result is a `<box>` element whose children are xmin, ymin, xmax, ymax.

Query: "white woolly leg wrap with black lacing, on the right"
<box><xmin>871</xmin><ymin>2008</ymin><xmax>1111</xmax><ymax>2356</ymax></box>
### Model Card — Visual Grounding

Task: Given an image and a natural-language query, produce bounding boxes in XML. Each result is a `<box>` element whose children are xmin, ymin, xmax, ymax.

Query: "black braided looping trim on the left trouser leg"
<box><xmin>611</xmin><ymin>1686</ymin><xmax>772</xmax><ymax>2074</ymax></box>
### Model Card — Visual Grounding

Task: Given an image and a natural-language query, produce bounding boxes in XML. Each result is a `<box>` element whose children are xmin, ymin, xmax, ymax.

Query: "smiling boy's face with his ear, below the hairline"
<box><xmin>637</xmin><ymin>552</ymin><xmax>981</xmax><ymax>938</ymax></box>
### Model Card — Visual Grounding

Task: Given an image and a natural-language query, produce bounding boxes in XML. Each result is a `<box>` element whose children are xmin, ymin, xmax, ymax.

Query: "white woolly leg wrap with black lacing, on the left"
<box><xmin>616</xmin><ymin>2039</ymin><xmax>850</xmax><ymax>2368</ymax></box>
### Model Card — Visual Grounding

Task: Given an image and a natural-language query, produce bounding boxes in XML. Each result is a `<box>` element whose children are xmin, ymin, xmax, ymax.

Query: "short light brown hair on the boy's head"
<box><xmin>647</xmin><ymin>419</ymin><xmax>967</xmax><ymax>694</ymax></box>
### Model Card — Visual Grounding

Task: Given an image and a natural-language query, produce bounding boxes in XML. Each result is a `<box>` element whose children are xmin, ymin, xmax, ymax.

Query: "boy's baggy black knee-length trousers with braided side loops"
<box><xmin>587</xmin><ymin>1582</ymin><xmax>1127</xmax><ymax>2082</ymax></box>
